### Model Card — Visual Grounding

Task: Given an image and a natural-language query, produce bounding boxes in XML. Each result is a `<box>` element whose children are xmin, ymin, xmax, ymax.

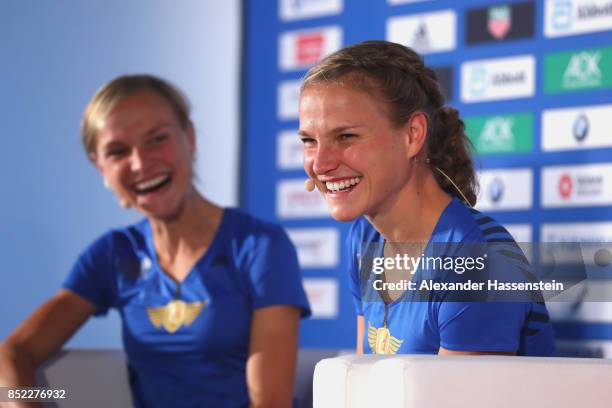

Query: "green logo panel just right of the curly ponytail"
<box><xmin>464</xmin><ymin>113</ymin><xmax>533</xmax><ymax>154</ymax></box>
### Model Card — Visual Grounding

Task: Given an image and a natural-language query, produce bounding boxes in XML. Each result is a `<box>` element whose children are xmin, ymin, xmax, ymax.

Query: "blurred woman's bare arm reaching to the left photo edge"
<box><xmin>0</xmin><ymin>289</ymin><xmax>95</xmax><ymax>387</ymax></box>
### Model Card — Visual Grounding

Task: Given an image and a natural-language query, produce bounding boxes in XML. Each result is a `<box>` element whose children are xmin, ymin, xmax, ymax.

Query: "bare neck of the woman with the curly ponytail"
<box><xmin>366</xmin><ymin>168</ymin><xmax>451</xmax><ymax>243</ymax></box>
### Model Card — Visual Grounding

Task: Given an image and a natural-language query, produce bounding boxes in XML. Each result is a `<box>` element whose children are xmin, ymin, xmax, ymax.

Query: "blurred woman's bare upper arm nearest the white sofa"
<box><xmin>247</xmin><ymin>306</ymin><xmax>300</xmax><ymax>408</ymax></box>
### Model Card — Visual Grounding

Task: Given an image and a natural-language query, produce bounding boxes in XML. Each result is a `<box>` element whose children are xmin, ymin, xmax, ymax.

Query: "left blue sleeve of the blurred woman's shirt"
<box><xmin>62</xmin><ymin>234</ymin><xmax>115</xmax><ymax>316</ymax></box>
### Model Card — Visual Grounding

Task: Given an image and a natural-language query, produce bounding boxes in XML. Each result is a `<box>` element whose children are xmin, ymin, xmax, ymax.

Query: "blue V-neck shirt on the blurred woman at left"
<box><xmin>64</xmin><ymin>209</ymin><xmax>310</xmax><ymax>408</ymax></box>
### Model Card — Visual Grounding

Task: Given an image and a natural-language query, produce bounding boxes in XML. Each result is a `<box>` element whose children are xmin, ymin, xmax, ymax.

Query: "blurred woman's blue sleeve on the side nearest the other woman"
<box><xmin>249</xmin><ymin>225</ymin><xmax>310</xmax><ymax>317</ymax></box>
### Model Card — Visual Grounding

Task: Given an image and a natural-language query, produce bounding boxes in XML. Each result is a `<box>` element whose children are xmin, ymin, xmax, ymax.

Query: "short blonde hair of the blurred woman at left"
<box><xmin>81</xmin><ymin>74</ymin><xmax>190</xmax><ymax>155</ymax></box>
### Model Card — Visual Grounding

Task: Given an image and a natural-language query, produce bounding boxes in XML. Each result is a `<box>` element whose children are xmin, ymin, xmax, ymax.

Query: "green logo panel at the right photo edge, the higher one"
<box><xmin>544</xmin><ymin>47</ymin><xmax>612</xmax><ymax>93</ymax></box>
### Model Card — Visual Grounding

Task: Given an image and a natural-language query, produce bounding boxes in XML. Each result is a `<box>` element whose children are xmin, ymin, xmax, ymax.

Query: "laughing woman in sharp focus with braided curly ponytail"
<box><xmin>299</xmin><ymin>41</ymin><xmax>553</xmax><ymax>355</ymax></box>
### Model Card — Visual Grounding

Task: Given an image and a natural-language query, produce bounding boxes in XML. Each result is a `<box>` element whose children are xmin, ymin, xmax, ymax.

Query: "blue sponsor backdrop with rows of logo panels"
<box><xmin>242</xmin><ymin>0</ymin><xmax>612</xmax><ymax>356</ymax></box>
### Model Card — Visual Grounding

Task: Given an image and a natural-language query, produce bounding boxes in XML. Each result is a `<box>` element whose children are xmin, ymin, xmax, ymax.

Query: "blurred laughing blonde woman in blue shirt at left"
<box><xmin>0</xmin><ymin>75</ymin><xmax>310</xmax><ymax>407</ymax></box>
